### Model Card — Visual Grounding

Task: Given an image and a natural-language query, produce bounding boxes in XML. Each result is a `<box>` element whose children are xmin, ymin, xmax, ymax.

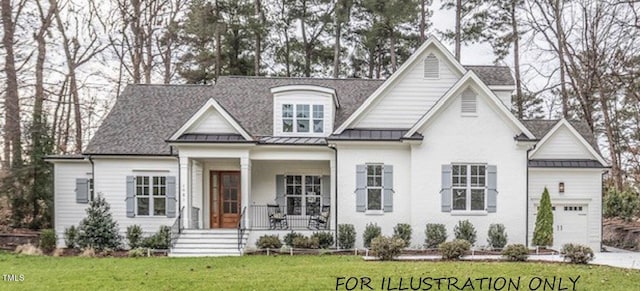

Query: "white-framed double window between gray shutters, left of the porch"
<box><xmin>135</xmin><ymin>176</ymin><xmax>167</xmax><ymax>216</ymax></box>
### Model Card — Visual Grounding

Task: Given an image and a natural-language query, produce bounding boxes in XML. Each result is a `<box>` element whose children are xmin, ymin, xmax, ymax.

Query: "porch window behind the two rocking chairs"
<box><xmin>285</xmin><ymin>175</ymin><xmax>322</xmax><ymax>215</ymax></box>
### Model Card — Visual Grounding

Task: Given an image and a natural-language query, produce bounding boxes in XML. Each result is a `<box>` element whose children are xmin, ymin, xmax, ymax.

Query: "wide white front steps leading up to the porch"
<box><xmin>169</xmin><ymin>229</ymin><xmax>249</xmax><ymax>257</ymax></box>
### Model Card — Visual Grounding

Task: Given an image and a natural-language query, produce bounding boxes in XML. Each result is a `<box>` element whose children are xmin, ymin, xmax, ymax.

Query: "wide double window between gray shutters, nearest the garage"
<box><xmin>451</xmin><ymin>165</ymin><xmax>487</xmax><ymax>211</ymax></box>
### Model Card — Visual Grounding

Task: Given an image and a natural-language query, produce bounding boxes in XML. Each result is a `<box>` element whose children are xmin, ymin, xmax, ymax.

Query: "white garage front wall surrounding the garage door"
<box><xmin>529</xmin><ymin>168</ymin><xmax>602</xmax><ymax>251</ymax></box>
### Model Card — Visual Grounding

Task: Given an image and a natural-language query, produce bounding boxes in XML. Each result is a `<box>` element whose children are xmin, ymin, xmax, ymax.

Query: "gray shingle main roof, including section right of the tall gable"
<box><xmin>84</xmin><ymin>66</ymin><xmax>513</xmax><ymax>155</ymax></box>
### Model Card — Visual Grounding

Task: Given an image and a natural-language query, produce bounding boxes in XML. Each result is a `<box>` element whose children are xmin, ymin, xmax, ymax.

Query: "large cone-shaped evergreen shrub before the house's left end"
<box><xmin>78</xmin><ymin>195</ymin><xmax>122</xmax><ymax>250</ymax></box>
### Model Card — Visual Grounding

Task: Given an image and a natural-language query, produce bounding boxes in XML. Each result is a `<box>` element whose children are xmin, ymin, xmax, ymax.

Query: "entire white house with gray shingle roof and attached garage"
<box><xmin>48</xmin><ymin>38</ymin><xmax>608</xmax><ymax>255</ymax></box>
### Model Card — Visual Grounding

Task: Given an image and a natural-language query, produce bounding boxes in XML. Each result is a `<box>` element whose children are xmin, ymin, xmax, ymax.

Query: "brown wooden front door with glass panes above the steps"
<box><xmin>211</xmin><ymin>172</ymin><xmax>241</xmax><ymax>228</ymax></box>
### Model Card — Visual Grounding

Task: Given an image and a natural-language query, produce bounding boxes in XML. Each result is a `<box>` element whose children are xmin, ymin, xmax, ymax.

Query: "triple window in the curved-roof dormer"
<box><xmin>282</xmin><ymin>104</ymin><xmax>324</xmax><ymax>133</ymax></box>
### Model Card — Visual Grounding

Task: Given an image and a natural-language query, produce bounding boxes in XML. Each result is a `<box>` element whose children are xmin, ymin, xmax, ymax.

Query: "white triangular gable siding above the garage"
<box><xmin>532</xmin><ymin>125</ymin><xmax>594</xmax><ymax>159</ymax></box>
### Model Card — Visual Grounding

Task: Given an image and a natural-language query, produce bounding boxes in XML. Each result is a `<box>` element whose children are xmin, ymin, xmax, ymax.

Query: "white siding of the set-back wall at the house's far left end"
<box><xmin>53</xmin><ymin>161</ymin><xmax>91</xmax><ymax>247</ymax></box>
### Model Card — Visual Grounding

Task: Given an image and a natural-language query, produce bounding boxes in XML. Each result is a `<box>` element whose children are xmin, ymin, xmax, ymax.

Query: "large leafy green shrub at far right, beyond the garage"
<box><xmin>604</xmin><ymin>187</ymin><xmax>640</xmax><ymax>221</ymax></box>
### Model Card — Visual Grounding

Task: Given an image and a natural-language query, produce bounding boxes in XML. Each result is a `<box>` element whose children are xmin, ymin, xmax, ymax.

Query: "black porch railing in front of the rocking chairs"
<box><xmin>249</xmin><ymin>205</ymin><xmax>330</xmax><ymax>230</ymax></box>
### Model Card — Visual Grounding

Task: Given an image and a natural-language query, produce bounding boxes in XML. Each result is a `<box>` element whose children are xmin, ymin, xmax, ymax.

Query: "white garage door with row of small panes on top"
<box><xmin>553</xmin><ymin>204</ymin><xmax>587</xmax><ymax>250</ymax></box>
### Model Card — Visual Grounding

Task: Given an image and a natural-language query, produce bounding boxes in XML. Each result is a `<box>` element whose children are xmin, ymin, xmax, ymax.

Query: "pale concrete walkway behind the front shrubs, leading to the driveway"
<box><xmin>363</xmin><ymin>248</ymin><xmax>640</xmax><ymax>270</ymax></box>
